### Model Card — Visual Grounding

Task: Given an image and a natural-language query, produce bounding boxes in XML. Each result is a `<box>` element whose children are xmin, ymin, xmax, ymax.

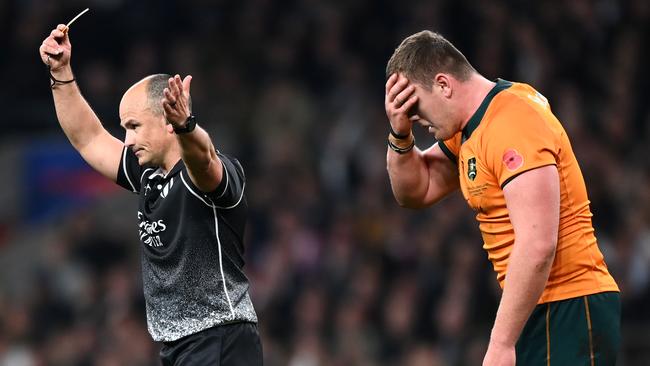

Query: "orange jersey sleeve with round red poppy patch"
<box><xmin>483</xmin><ymin>103</ymin><xmax>559</xmax><ymax>188</ymax></box>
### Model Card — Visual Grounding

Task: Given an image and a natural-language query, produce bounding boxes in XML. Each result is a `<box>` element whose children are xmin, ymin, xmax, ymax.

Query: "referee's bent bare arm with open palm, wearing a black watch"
<box><xmin>161</xmin><ymin>75</ymin><xmax>223</xmax><ymax>192</ymax></box>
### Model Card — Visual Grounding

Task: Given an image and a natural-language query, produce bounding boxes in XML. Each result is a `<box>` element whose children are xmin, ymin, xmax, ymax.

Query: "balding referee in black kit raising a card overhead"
<box><xmin>40</xmin><ymin>24</ymin><xmax>262</xmax><ymax>366</ymax></box>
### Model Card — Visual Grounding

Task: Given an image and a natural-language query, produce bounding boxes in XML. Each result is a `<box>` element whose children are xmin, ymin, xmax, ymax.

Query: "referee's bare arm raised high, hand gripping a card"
<box><xmin>39</xmin><ymin>24</ymin><xmax>124</xmax><ymax>181</ymax></box>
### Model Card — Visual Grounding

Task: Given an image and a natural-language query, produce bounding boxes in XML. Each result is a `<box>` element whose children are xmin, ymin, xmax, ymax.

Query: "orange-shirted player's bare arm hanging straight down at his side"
<box><xmin>484</xmin><ymin>165</ymin><xmax>560</xmax><ymax>365</ymax></box>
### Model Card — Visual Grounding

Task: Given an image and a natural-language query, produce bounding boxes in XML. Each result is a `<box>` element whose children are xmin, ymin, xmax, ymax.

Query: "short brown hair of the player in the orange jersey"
<box><xmin>386</xmin><ymin>30</ymin><xmax>476</xmax><ymax>88</ymax></box>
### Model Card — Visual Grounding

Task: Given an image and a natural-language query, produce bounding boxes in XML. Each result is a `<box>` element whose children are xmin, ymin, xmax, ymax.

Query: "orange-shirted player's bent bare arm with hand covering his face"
<box><xmin>384</xmin><ymin>74</ymin><xmax>459</xmax><ymax>208</ymax></box>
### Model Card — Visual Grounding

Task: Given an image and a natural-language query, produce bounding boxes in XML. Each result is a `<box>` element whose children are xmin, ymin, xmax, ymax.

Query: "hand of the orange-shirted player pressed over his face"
<box><xmin>384</xmin><ymin>73</ymin><xmax>418</xmax><ymax>135</ymax></box>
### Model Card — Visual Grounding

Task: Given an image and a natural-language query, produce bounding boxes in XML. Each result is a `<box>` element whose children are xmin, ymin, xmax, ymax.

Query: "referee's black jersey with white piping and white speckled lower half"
<box><xmin>117</xmin><ymin>148</ymin><xmax>257</xmax><ymax>341</ymax></box>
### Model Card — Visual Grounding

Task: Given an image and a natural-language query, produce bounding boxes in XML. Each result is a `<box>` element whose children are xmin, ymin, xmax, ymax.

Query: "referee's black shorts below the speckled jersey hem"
<box><xmin>160</xmin><ymin>323</ymin><xmax>262</xmax><ymax>366</ymax></box>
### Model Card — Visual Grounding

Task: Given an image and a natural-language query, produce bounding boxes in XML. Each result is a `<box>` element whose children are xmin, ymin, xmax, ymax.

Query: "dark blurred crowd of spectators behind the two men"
<box><xmin>0</xmin><ymin>0</ymin><xmax>650</xmax><ymax>366</ymax></box>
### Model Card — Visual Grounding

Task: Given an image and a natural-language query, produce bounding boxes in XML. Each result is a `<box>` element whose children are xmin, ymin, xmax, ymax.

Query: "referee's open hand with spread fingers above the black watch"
<box><xmin>161</xmin><ymin>74</ymin><xmax>192</xmax><ymax>127</ymax></box>
